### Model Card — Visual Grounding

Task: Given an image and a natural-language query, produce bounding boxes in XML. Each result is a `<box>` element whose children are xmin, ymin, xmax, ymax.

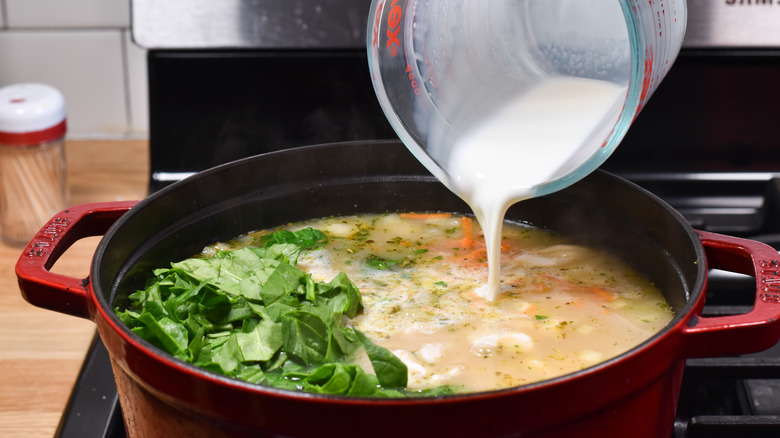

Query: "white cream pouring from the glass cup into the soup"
<box><xmin>446</xmin><ymin>78</ymin><xmax>626</xmax><ymax>301</ymax></box>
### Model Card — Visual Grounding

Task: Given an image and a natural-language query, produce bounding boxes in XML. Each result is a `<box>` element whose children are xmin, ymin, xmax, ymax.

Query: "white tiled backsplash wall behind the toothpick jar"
<box><xmin>0</xmin><ymin>0</ymin><xmax>149</xmax><ymax>139</ymax></box>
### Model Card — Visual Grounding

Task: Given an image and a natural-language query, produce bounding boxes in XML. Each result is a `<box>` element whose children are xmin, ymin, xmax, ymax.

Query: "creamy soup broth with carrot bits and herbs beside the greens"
<box><xmin>204</xmin><ymin>213</ymin><xmax>673</xmax><ymax>392</ymax></box>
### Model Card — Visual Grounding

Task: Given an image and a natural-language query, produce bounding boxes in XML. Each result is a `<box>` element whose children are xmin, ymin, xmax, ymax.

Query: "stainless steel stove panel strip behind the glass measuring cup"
<box><xmin>131</xmin><ymin>0</ymin><xmax>780</xmax><ymax>49</ymax></box>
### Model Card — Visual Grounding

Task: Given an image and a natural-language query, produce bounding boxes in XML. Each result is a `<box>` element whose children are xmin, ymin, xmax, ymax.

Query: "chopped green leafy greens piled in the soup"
<box><xmin>115</xmin><ymin>228</ymin><xmax>451</xmax><ymax>397</ymax></box>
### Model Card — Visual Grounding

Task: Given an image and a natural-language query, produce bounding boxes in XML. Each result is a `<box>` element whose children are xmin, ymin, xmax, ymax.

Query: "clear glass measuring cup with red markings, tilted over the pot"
<box><xmin>368</xmin><ymin>0</ymin><xmax>686</xmax><ymax>196</ymax></box>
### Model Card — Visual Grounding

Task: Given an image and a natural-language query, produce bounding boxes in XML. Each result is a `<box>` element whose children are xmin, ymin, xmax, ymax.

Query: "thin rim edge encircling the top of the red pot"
<box><xmin>88</xmin><ymin>140</ymin><xmax>707</xmax><ymax>406</ymax></box>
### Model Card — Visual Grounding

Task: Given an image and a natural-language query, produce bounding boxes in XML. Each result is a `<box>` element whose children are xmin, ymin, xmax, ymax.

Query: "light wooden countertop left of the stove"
<box><xmin>0</xmin><ymin>140</ymin><xmax>149</xmax><ymax>438</ymax></box>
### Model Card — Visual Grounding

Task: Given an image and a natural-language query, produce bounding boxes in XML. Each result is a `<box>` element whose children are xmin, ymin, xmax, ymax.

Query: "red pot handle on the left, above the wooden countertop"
<box><xmin>16</xmin><ymin>201</ymin><xmax>138</xmax><ymax>318</ymax></box>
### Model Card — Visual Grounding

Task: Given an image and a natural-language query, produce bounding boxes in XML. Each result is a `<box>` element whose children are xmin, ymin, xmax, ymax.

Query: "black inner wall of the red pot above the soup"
<box><xmin>92</xmin><ymin>141</ymin><xmax>706</xmax><ymax>332</ymax></box>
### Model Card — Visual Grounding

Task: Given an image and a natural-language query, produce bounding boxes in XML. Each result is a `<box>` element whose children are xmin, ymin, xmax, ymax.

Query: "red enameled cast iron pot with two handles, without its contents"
<box><xmin>17</xmin><ymin>142</ymin><xmax>780</xmax><ymax>438</ymax></box>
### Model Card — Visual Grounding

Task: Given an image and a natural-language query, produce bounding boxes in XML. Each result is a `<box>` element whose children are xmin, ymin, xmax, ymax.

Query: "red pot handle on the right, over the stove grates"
<box><xmin>683</xmin><ymin>231</ymin><xmax>780</xmax><ymax>357</ymax></box>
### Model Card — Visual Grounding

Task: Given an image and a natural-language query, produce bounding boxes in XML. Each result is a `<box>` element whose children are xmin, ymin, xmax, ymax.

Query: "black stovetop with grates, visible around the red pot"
<box><xmin>56</xmin><ymin>173</ymin><xmax>780</xmax><ymax>438</ymax></box>
